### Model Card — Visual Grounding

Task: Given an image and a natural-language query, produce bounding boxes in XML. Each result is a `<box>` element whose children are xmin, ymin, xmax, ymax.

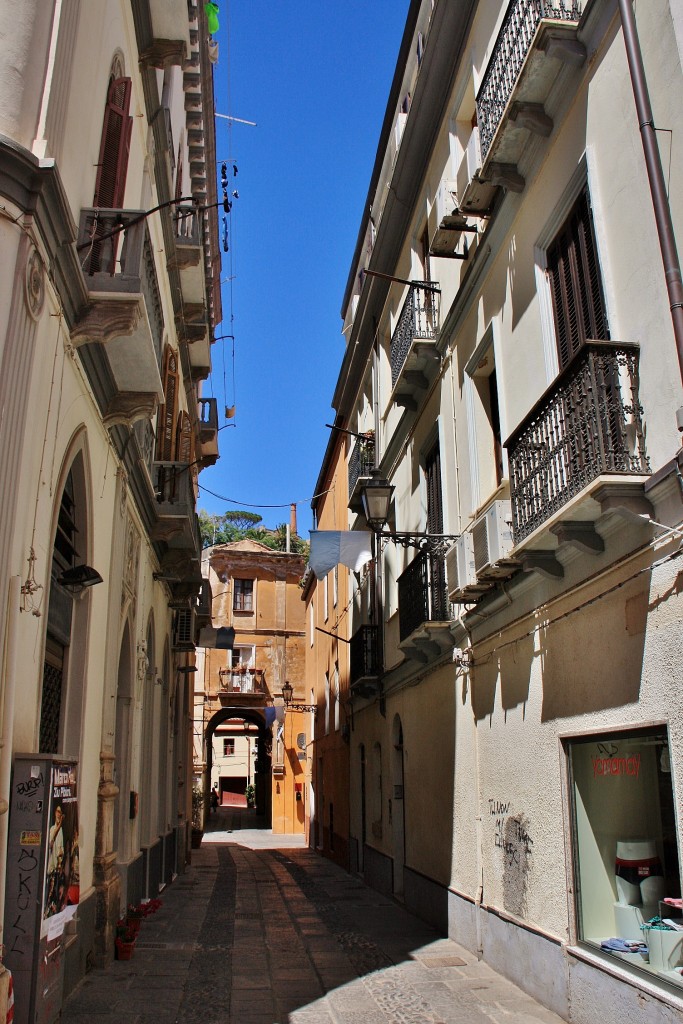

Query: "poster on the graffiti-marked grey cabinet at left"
<box><xmin>41</xmin><ymin>762</ymin><xmax>80</xmax><ymax>939</ymax></box>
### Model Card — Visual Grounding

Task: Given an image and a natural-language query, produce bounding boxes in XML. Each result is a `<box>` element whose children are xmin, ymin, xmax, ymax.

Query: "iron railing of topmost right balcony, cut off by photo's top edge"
<box><xmin>476</xmin><ymin>0</ymin><xmax>584</xmax><ymax>160</ymax></box>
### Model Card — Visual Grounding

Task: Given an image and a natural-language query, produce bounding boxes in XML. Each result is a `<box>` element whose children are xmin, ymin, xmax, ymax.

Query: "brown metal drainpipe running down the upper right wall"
<box><xmin>618</xmin><ymin>0</ymin><xmax>683</xmax><ymax>430</ymax></box>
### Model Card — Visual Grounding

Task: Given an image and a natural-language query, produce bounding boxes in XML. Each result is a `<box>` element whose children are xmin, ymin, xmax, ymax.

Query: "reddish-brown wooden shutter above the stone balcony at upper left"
<box><xmin>93</xmin><ymin>78</ymin><xmax>133</xmax><ymax>210</ymax></box>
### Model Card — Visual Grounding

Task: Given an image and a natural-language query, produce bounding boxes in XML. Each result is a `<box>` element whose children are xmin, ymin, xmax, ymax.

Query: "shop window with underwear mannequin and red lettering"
<box><xmin>568</xmin><ymin>726</ymin><xmax>683</xmax><ymax>984</ymax></box>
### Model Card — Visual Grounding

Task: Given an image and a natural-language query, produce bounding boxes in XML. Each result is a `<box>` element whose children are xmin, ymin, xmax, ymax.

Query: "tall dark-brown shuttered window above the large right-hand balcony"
<box><xmin>547</xmin><ymin>185</ymin><xmax>609</xmax><ymax>370</ymax></box>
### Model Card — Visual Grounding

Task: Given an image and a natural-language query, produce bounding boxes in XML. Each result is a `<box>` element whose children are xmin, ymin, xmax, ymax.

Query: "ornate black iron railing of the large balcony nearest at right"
<box><xmin>506</xmin><ymin>341</ymin><xmax>649</xmax><ymax>544</ymax></box>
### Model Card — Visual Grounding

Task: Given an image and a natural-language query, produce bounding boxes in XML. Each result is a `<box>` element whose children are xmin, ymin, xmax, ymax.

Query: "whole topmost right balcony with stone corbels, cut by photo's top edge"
<box><xmin>476</xmin><ymin>0</ymin><xmax>586</xmax><ymax>191</ymax></box>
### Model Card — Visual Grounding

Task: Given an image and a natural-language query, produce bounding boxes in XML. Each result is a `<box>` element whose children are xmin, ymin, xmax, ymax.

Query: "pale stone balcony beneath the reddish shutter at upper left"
<box><xmin>72</xmin><ymin>209</ymin><xmax>164</xmax><ymax>426</ymax></box>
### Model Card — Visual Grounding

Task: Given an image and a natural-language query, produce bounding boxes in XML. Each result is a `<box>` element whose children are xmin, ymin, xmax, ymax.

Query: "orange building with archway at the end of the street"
<box><xmin>195</xmin><ymin>540</ymin><xmax>312</xmax><ymax>834</ymax></box>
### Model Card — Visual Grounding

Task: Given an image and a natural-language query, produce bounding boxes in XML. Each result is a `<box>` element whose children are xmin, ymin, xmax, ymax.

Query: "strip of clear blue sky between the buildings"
<box><xmin>199</xmin><ymin>0</ymin><xmax>410</xmax><ymax>538</ymax></box>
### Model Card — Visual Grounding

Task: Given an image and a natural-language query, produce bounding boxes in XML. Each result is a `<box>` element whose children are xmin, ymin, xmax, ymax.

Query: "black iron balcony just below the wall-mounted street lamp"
<box><xmin>397</xmin><ymin>552</ymin><xmax>453</xmax><ymax>663</ymax></box>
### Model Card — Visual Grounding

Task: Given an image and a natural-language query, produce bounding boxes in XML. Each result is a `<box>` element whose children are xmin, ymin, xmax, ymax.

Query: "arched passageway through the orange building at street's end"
<box><xmin>204</xmin><ymin>708</ymin><xmax>272</xmax><ymax>828</ymax></box>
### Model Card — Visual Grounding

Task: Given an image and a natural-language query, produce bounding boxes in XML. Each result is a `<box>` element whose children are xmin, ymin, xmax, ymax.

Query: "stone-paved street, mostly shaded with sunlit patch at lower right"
<box><xmin>61</xmin><ymin>808</ymin><xmax>560</xmax><ymax>1024</ymax></box>
